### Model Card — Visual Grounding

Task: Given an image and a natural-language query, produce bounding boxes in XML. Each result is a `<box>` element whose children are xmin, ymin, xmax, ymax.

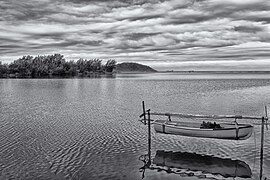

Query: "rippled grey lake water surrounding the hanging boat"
<box><xmin>0</xmin><ymin>73</ymin><xmax>270</xmax><ymax>180</ymax></box>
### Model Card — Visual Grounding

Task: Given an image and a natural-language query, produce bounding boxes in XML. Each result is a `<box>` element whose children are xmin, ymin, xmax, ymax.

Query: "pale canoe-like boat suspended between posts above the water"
<box><xmin>153</xmin><ymin>120</ymin><xmax>253</xmax><ymax>140</ymax></box>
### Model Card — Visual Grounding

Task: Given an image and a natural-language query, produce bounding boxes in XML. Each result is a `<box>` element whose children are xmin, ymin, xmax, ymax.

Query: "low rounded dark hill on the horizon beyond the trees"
<box><xmin>116</xmin><ymin>62</ymin><xmax>157</xmax><ymax>73</ymax></box>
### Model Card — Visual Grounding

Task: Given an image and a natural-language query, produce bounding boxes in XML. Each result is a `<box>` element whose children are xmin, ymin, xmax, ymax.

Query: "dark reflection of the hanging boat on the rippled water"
<box><xmin>140</xmin><ymin>150</ymin><xmax>252</xmax><ymax>178</ymax></box>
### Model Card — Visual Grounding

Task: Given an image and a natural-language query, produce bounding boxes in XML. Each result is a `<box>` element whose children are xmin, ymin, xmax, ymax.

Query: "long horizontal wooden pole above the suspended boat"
<box><xmin>151</xmin><ymin>112</ymin><xmax>262</xmax><ymax>120</ymax></box>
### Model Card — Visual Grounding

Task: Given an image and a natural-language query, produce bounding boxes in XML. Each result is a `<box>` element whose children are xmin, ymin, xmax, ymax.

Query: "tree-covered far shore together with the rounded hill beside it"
<box><xmin>0</xmin><ymin>54</ymin><xmax>156</xmax><ymax>78</ymax></box>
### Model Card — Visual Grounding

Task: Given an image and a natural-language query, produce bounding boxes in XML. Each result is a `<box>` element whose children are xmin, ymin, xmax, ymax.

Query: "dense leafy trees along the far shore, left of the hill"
<box><xmin>0</xmin><ymin>54</ymin><xmax>116</xmax><ymax>77</ymax></box>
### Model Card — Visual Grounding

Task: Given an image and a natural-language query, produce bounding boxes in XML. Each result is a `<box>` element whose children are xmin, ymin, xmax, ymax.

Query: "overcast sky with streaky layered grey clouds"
<box><xmin>0</xmin><ymin>0</ymin><xmax>270</xmax><ymax>70</ymax></box>
